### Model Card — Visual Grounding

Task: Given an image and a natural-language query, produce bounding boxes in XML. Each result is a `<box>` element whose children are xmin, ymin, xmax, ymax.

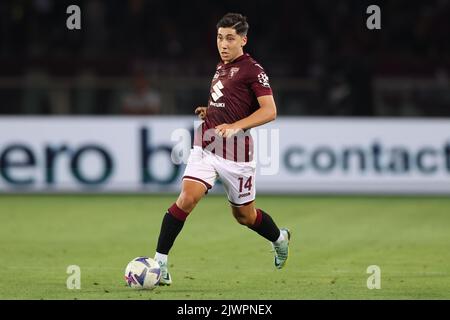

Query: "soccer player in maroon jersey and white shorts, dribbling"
<box><xmin>155</xmin><ymin>13</ymin><xmax>290</xmax><ymax>285</ymax></box>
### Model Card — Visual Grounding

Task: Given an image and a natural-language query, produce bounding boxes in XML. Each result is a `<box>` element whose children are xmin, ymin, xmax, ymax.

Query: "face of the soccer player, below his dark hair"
<box><xmin>217</xmin><ymin>28</ymin><xmax>247</xmax><ymax>63</ymax></box>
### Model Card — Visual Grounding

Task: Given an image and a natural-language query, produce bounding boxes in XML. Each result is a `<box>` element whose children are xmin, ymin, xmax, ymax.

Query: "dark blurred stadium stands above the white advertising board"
<box><xmin>0</xmin><ymin>0</ymin><xmax>450</xmax><ymax>117</ymax></box>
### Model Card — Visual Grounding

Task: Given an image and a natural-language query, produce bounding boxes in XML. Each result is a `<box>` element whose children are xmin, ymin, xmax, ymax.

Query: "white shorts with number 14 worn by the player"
<box><xmin>183</xmin><ymin>146</ymin><xmax>256</xmax><ymax>207</ymax></box>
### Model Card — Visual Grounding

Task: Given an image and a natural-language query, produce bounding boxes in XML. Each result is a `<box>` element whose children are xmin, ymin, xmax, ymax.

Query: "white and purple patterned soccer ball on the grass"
<box><xmin>125</xmin><ymin>257</ymin><xmax>161</xmax><ymax>290</ymax></box>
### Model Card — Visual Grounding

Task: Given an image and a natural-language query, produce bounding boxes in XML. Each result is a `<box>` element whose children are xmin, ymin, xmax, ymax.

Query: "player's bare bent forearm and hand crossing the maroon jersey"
<box><xmin>215</xmin><ymin>95</ymin><xmax>277</xmax><ymax>138</ymax></box>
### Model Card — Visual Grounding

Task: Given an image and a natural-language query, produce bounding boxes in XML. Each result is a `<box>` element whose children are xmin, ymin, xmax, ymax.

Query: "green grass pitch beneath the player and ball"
<box><xmin>0</xmin><ymin>195</ymin><xmax>450</xmax><ymax>300</ymax></box>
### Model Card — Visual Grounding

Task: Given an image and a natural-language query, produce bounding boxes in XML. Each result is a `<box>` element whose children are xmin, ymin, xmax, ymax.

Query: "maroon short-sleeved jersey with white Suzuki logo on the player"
<box><xmin>196</xmin><ymin>53</ymin><xmax>272</xmax><ymax>162</ymax></box>
